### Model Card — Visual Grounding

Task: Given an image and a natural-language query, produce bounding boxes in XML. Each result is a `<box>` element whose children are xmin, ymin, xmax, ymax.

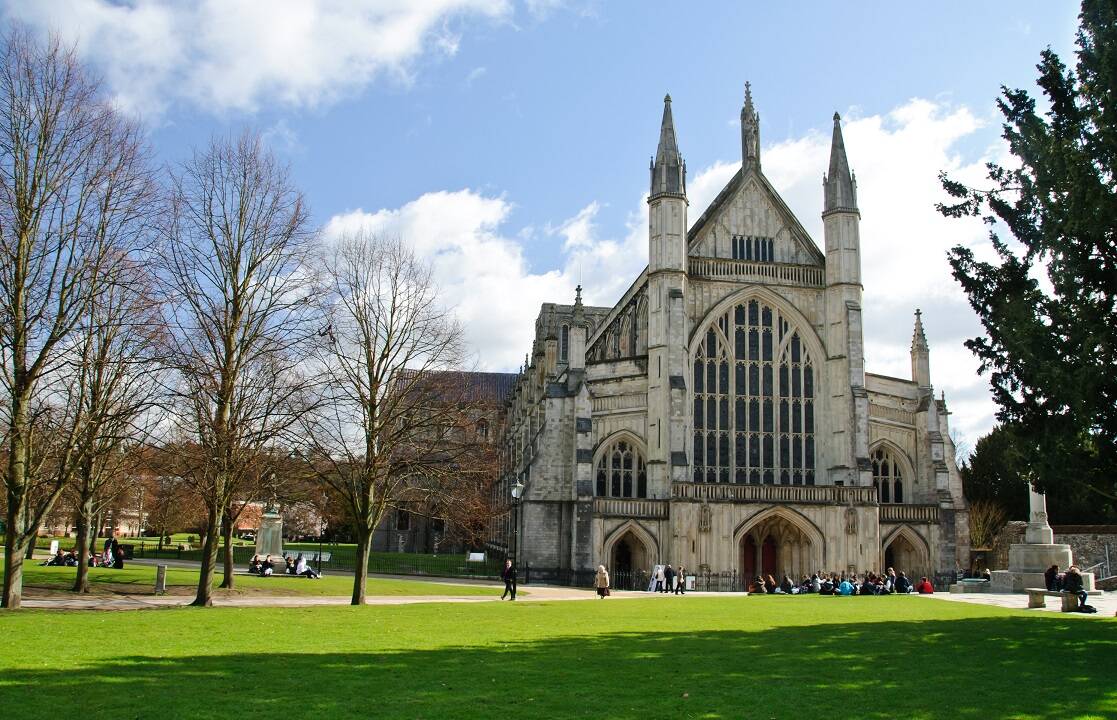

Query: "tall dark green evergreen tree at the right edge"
<box><xmin>938</xmin><ymin>0</ymin><xmax>1117</xmax><ymax>513</ymax></box>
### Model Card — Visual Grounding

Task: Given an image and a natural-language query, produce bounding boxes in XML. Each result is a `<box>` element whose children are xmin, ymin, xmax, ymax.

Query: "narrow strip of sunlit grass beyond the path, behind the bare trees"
<box><xmin>23</xmin><ymin>565</ymin><xmax>503</xmax><ymax>597</ymax></box>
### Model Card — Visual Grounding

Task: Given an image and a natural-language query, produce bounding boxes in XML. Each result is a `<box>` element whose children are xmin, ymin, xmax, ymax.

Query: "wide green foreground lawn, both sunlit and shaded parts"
<box><xmin>0</xmin><ymin>596</ymin><xmax>1117</xmax><ymax>720</ymax></box>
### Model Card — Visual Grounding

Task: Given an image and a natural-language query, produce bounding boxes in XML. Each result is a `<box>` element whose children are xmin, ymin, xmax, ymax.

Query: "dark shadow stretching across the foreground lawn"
<box><xmin>0</xmin><ymin>617</ymin><xmax>1117</xmax><ymax>720</ymax></box>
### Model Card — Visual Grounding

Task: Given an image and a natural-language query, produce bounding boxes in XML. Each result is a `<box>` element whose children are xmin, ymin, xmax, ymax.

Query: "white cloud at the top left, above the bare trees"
<box><xmin>6</xmin><ymin>0</ymin><xmax>510</xmax><ymax>116</ymax></box>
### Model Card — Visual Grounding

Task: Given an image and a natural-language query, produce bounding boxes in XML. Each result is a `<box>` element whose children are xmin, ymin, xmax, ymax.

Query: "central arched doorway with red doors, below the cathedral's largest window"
<box><xmin>739</xmin><ymin>511</ymin><xmax>822</xmax><ymax>582</ymax></box>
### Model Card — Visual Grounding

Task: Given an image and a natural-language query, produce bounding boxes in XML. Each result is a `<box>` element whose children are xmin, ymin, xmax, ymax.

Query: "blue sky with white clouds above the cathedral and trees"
<box><xmin>0</xmin><ymin>0</ymin><xmax>1078</xmax><ymax>447</ymax></box>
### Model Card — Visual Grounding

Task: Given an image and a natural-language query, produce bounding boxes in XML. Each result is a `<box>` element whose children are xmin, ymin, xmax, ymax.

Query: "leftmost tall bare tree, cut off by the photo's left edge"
<box><xmin>0</xmin><ymin>27</ymin><xmax>156</xmax><ymax>608</ymax></box>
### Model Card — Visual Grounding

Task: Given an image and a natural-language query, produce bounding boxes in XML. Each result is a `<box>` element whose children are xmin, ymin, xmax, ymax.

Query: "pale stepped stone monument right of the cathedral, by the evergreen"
<box><xmin>990</xmin><ymin>484</ymin><xmax>1094</xmax><ymax>593</ymax></box>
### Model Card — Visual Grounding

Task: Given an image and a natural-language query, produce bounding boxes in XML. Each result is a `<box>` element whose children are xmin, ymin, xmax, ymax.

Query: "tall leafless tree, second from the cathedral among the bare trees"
<box><xmin>161</xmin><ymin>133</ymin><xmax>315</xmax><ymax>606</ymax></box>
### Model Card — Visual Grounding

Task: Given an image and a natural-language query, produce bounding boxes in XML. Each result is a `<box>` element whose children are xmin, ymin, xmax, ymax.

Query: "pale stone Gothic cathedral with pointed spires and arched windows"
<box><xmin>499</xmin><ymin>84</ymin><xmax>968</xmax><ymax>587</ymax></box>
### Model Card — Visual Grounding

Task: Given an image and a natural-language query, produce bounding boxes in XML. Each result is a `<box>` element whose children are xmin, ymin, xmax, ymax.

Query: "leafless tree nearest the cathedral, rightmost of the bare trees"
<box><xmin>297</xmin><ymin>232</ymin><xmax>472</xmax><ymax>605</ymax></box>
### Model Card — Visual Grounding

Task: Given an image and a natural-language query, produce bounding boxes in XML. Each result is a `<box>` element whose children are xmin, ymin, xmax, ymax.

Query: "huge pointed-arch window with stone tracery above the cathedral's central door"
<box><xmin>694</xmin><ymin>296</ymin><xmax>817</xmax><ymax>484</ymax></box>
